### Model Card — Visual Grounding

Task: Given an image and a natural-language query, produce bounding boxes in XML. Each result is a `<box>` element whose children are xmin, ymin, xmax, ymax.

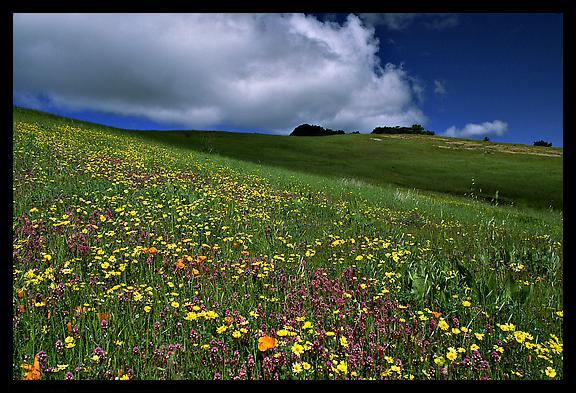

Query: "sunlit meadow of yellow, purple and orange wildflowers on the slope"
<box><xmin>12</xmin><ymin>108</ymin><xmax>563</xmax><ymax>380</ymax></box>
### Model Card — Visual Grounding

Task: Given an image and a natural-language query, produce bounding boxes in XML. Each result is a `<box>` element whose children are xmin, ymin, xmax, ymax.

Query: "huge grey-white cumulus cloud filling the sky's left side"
<box><xmin>13</xmin><ymin>14</ymin><xmax>426</xmax><ymax>133</ymax></box>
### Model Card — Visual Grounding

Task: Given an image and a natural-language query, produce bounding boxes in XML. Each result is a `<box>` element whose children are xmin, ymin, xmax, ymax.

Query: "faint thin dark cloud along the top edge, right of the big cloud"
<box><xmin>359</xmin><ymin>12</ymin><xmax>460</xmax><ymax>30</ymax></box>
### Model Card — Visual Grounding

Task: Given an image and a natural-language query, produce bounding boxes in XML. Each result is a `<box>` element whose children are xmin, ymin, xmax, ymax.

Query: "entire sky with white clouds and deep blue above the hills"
<box><xmin>13</xmin><ymin>13</ymin><xmax>563</xmax><ymax>146</ymax></box>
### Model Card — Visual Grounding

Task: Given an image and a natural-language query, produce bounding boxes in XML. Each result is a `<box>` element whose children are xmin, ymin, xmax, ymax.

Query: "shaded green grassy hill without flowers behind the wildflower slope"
<box><xmin>126</xmin><ymin>125</ymin><xmax>563</xmax><ymax>209</ymax></box>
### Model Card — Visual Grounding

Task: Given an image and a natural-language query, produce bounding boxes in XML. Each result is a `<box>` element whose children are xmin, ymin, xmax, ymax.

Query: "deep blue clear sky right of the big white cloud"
<box><xmin>364</xmin><ymin>14</ymin><xmax>563</xmax><ymax>146</ymax></box>
